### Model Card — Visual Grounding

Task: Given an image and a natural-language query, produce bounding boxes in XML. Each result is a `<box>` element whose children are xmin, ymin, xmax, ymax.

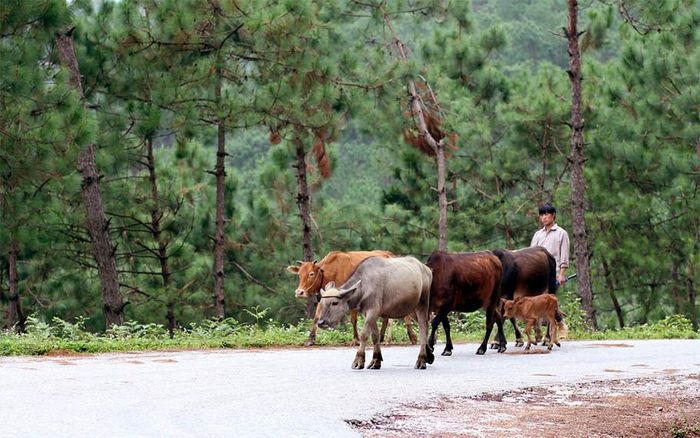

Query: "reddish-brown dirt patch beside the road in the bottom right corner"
<box><xmin>348</xmin><ymin>374</ymin><xmax>700</xmax><ymax>438</ymax></box>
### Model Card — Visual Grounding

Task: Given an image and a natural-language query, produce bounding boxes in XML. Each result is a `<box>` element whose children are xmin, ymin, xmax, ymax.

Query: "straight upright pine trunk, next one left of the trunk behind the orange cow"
<box><xmin>214</xmin><ymin>69</ymin><xmax>226</xmax><ymax>318</ymax></box>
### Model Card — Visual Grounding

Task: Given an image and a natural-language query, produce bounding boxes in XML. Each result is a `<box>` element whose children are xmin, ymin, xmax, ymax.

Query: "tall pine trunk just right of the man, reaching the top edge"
<box><xmin>566</xmin><ymin>0</ymin><xmax>597</xmax><ymax>330</ymax></box>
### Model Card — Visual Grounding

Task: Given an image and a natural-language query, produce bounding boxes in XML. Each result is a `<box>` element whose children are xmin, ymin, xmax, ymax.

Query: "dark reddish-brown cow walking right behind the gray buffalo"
<box><xmin>426</xmin><ymin>251</ymin><xmax>506</xmax><ymax>356</ymax></box>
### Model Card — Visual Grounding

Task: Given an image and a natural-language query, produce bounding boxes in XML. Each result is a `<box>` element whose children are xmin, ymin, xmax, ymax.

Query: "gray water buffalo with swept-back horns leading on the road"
<box><xmin>317</xmin><ymin>257</ymin><xmax>435</xmax><ymax>370</ymax></box>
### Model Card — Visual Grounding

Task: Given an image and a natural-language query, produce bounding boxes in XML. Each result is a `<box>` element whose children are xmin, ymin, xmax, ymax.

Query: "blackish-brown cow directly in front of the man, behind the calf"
<box><xmin>492</xmin><ymin>246</ymin><xmax>563</xmax><ymax>348</ymax></box>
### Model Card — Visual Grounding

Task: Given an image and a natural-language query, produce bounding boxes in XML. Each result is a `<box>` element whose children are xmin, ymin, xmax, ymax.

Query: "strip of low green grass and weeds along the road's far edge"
<box><xmin>0</xmin><ymin>295</ymin><xmax>700</xmax><ymax>356</ymax></box>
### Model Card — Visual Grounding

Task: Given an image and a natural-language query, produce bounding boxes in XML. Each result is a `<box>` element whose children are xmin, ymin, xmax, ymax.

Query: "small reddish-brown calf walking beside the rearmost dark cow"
<box><xmin>502</xmin><ymin>294</ymin><xmax>562</xmax><ymax>350</ymax></box>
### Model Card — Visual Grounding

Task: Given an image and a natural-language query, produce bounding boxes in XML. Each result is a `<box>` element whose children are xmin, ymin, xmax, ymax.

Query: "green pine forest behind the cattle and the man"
<box><xmin>0</xmin><ymin>0</ymin><xmax>700</xmax><ymax>338</ymax></box>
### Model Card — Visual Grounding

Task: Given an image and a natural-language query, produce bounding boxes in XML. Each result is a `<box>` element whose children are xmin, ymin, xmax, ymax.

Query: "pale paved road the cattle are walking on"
<box><xmin>0</xmin><ymin>340</ymin><xmax>700</xmax><ymax>438</ymax></box>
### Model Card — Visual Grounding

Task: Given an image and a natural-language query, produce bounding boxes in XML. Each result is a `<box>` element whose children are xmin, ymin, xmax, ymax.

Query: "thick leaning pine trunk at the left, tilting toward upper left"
<box><xmin>56</xmin><ymin>29</ymin><xmax>124</xmax><ymax>328</ymax></box>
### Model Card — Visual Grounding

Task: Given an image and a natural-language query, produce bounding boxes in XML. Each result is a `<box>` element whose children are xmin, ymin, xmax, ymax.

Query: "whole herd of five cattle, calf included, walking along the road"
<box><xmin>287</xmin><ymin>247</ymin><xmax>565</xmax><ymax>369</ymax></box>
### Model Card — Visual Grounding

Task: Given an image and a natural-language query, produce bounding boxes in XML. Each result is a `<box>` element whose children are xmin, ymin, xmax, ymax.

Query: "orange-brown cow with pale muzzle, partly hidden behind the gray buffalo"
<box><xmin>287</xmin><ymin>250</ymin><xmax>416</xmax><ymax>347</ymax></box>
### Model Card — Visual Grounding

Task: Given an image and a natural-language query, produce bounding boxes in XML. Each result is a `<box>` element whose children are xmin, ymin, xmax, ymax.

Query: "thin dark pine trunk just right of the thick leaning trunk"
<box><xmin>146</xmin><ymin>137</ymin><xmax>177</xmax><ymax>338</ymax></box>
